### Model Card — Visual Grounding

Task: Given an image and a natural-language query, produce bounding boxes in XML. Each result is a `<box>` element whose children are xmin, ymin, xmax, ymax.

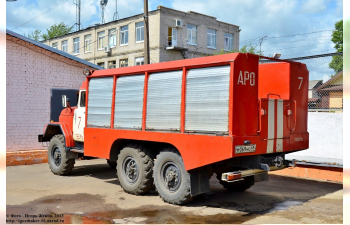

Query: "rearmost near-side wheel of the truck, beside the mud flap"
<box><xmin>153</xmin><ymin>148</ymin><xmax>192</xmax><ymax>205</ymax></box>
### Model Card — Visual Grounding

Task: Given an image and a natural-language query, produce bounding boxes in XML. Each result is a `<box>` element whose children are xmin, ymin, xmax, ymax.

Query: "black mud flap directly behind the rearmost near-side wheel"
<box><xmin>190</xmin><ymin>171</ymin><xmax>210</xmax><ymax>196</ymax></box>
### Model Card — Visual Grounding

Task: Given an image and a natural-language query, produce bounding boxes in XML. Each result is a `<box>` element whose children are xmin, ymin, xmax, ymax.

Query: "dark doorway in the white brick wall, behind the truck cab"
<box><xmin>50</xmin><ymin>88</ymin><xmax>79</xmax><ymax>122</ymax></box>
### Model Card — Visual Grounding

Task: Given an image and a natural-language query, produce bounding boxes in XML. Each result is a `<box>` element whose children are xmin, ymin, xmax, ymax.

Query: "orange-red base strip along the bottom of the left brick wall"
<box><xmin>6</xmin><ymin>150</ymin><xmax>48</xmax><ymax>166</ymax></box>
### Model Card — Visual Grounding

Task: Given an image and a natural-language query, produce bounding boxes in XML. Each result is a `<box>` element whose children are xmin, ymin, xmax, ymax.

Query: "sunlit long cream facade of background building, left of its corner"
<box><xmin>44</xmin><ymin>11</ymin><xmax>160</xmax><ymax>68</ymax></box>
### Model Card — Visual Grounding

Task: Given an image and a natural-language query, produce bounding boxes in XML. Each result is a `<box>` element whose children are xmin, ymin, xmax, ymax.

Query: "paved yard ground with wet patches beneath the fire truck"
<box><xmin>6</xmin><ymin>159</ymin><xmax>343</xmax><ymax>224</ymax></box>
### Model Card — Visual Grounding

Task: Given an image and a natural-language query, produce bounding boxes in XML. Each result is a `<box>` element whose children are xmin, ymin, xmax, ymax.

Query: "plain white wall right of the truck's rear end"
<box><xmin>286</xmin><ymin>112</ymin><xmax>343</xmax><ymax>165</ymax></box>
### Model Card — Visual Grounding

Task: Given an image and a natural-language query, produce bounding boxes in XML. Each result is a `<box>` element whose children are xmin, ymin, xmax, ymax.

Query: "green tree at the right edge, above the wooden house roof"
<box><xmin>329</xmin><ymin>20</ymin><xmax>343</xmax><ymax>74</ymax></box>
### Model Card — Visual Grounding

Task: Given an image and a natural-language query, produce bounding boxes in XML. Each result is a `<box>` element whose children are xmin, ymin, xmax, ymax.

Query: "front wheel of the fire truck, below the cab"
<box><xmin>47</xmin><ymin>134</ymin><xmax>75</xmax><ymax>175</ymax></box>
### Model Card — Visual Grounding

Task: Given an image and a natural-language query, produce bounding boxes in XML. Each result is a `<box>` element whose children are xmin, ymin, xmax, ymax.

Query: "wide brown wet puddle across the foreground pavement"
<box><xmin>6</xmin><ymin>194</ymin><xmax>303</xmax><ymax>224</ymax></box>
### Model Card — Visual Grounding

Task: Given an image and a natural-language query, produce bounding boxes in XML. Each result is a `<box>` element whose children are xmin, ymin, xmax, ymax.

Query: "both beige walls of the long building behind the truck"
<box><xmin>44</xmin><ymin>6</ymin><xmax>239</xmax><ymax>68</ymax></box>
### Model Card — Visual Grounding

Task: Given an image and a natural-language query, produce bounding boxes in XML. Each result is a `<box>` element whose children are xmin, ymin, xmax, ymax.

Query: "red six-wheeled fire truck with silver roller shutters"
<box><xmin>38</xmin><ymin>53</ymin><xmax>309</xmax><ymax>204</ymax></box>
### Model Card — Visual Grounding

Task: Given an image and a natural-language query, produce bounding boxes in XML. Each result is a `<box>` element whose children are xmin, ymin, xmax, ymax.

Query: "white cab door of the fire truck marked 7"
<box><xmin>73</xmin><ymin>90</ymin><xmax>86</xmax><ymax>142</ymax></box>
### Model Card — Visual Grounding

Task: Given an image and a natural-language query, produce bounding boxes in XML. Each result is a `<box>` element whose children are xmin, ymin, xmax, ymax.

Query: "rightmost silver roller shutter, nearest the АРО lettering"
<box><xmin>185</xmin><ymin>65</ymin><xmax>230</xmax><ymax>133</ymax></box>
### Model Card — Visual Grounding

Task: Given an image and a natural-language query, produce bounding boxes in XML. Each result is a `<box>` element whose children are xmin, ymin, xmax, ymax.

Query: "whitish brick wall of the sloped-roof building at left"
<box><xmin>6</xmin><ymin>35</ymin><xmax>95</xmax><ymax>151</ymax></box>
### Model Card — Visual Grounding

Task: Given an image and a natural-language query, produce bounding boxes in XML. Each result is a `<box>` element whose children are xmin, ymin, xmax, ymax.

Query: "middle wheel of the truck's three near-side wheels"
<box><xmin>117</xmin><ymin>145</ymin><xmax>154</xmax><ymax>195</ymax></box>
